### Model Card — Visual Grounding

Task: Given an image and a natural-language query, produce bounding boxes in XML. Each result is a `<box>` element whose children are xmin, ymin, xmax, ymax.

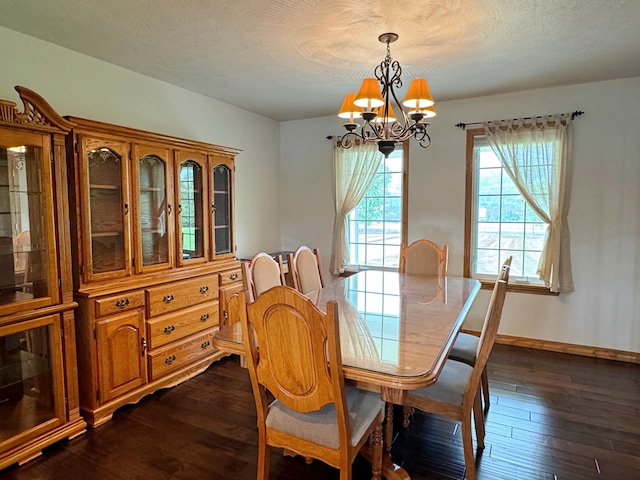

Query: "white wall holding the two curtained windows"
<box><xmin>280</xmin><ymin>77</ymin><xmax>640</xmax><ymax>352</ymax></box>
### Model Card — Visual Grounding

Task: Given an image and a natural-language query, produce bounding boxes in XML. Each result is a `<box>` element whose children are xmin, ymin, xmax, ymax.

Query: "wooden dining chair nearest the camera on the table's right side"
<box><xmin>402</xmin><ymin>258</ymin><xmax>509</xmax><ymax>480</ymax></box>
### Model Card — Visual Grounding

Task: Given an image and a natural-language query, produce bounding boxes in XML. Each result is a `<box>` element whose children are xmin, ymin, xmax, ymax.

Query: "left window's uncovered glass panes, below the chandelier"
<box><xmin>348</xmin><ymin>142</ymin><xmax>408</xmax><ymax>269</ymax></box>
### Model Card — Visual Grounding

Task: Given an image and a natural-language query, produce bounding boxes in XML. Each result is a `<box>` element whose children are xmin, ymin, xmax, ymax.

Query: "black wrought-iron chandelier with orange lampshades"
<box><xmin>338</xmin><ymin>33</ymin><xmax>436</xmax><ymax>157</ymax></box>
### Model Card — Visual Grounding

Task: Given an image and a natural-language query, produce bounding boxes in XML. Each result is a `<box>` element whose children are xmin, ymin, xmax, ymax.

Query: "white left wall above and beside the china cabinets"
<box><xmin>0</xmin><ymin>27</ymin><xmax>280</xmax><ymax>257</ymax></box>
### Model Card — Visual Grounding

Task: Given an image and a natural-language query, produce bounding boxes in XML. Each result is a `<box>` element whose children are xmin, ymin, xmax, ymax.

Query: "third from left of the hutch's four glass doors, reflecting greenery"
<box><xmin>176</xmin><ymin>154</ymin><xmax>208</xmax><ymax>263</ymax></box>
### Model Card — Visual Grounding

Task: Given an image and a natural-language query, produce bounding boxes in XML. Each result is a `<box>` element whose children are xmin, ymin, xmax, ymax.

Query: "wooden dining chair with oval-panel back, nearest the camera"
<box><xmin>239</xmin><ymin>286</ymin><xmax>384</xmax><ymax>480</ymax></box>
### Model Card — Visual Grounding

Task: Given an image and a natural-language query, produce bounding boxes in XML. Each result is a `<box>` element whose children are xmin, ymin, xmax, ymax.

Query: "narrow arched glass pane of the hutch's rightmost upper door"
<box><xmin>212</xmin><ymin>164</ymin><xmax>233</xmax><ymax>255</ymax></box>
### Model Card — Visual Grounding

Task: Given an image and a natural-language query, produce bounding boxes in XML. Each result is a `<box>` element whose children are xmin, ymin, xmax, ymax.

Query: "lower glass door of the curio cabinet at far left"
<box><xmin>0</xmin><ymin>315</ymin><xmax>64</xmax><ymax>451</ymax></box>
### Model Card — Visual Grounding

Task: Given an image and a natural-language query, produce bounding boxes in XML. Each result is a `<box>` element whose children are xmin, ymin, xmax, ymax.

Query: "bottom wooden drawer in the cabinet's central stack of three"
<box><xmin>149</xmin><ymin>330</ymin><xmax>215</xmax><ymax>381</ymax></box>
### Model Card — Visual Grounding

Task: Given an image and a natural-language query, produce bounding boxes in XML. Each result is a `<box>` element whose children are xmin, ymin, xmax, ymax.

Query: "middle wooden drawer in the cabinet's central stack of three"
<box><xmin>147</xmin><ymin>302</ymin><xmax>219</xmax><ymax>349</ymax></box>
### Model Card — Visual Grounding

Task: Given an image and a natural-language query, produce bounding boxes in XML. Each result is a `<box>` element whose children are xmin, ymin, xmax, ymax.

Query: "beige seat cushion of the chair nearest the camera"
<box><xmin>266</xmin><ymin>387</ymin><xmax>384</xmax><ymax>449</ymax></box>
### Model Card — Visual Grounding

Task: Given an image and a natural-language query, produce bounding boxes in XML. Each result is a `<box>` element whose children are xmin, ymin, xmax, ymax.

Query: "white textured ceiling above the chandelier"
<box><xmin>0</xmin><ymin>0</ymin><xmax>640</xmax><ymax>120</ymax></box>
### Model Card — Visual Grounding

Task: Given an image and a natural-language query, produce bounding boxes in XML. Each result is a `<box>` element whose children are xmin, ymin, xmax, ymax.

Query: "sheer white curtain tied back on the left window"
<box><xmin>331</xmin><ymin>143</ymin><xmax>384</xmax><ymax>275</ymax></box>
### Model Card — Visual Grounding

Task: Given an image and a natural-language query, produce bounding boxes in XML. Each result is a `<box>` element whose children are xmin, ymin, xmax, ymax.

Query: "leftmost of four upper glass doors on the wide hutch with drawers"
<box><xmin>84</xmin><ymin>136</ymin><xmax>130</xmax><ymax>277</ymax></box>
